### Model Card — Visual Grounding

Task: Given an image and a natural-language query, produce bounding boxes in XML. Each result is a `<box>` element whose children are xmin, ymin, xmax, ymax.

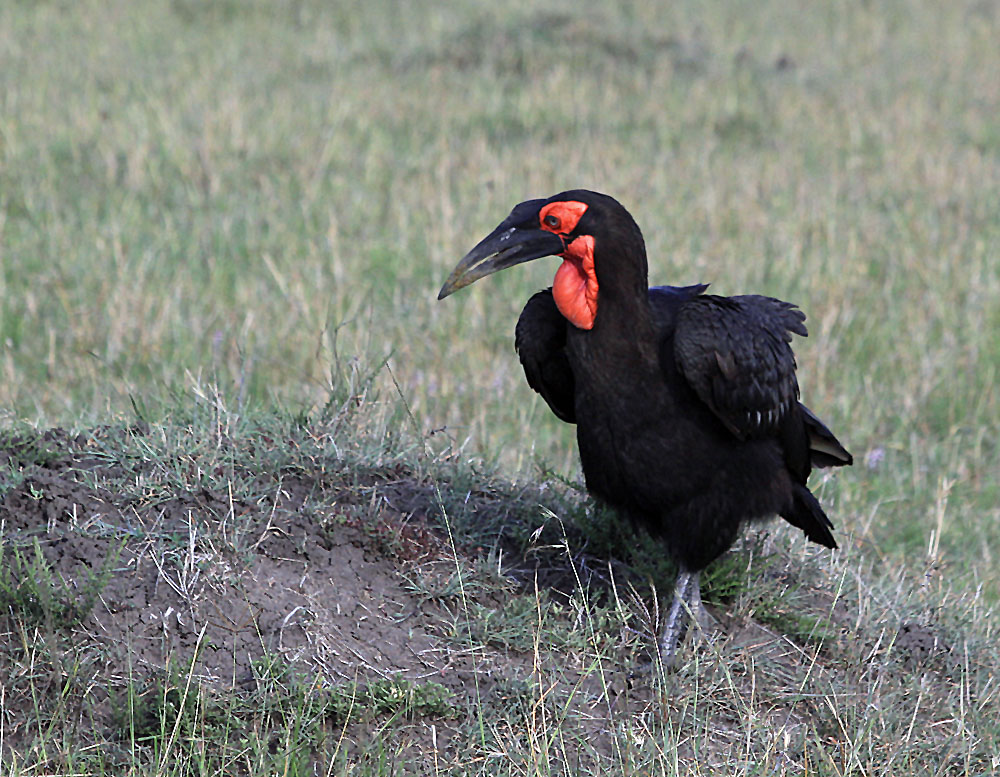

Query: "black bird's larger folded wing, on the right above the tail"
<box><xmin>674</xmin><ymin>294</ymin><xmax>806</xmax><ymax>440</ymax></box>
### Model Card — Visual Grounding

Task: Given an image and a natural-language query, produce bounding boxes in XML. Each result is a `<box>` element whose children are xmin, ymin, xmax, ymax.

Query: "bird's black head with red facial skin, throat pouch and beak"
<box><xmin>438</xmin><ymin>189</ymin><xmax>646</xmax><ymax>329</ymax></box>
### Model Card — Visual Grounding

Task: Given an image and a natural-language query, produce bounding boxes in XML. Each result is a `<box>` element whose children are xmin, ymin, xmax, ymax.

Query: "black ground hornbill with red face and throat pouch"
<box><xmin>438</xmin><ymin>190</ymin><xmax>851</xmax><ymax>664</ymax></box>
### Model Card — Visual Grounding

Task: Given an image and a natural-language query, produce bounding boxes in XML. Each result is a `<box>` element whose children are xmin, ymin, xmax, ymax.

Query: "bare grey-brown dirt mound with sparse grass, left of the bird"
<box><xmin>0</xmin><ymin>430</ymin><xmax>556</xmax><ymax>746</ymax></box>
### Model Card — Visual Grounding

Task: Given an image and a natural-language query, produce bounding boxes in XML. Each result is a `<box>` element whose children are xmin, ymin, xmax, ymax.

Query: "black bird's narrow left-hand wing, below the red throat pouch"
<box><xmin>514</xmin><ymin>289</ymin><xmax>576</xmax><ymax>424</ymax></box>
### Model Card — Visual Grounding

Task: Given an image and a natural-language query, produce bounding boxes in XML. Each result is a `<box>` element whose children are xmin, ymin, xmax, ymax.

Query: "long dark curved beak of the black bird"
<box><xmin>438</xmin><ymin>224</ymin><xmax>565</xmax><ymax>299</ymax></box>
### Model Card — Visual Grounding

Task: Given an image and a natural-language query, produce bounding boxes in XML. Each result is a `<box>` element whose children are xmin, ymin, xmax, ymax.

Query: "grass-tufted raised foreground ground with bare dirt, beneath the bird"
<box><xmin>0</xmin><ymin>406</ymin><xmax>1000</xmax><ymax>775</ymax></box>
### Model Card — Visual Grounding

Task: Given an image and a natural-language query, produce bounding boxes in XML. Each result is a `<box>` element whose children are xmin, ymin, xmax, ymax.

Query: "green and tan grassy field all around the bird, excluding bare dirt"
<box><xmin>0</xmin><ymin>0</ymin><xmax>1000</xmax><ymax>777</ymax></box>
